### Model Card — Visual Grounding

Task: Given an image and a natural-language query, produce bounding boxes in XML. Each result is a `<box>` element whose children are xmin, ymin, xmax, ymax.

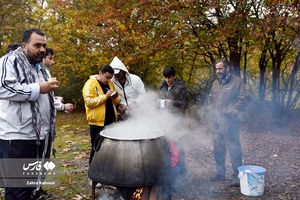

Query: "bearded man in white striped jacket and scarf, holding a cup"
<box><xmin>0</xmin><ymin>28</ymin><xmax>59</xmax><ymax>200</ymax></box>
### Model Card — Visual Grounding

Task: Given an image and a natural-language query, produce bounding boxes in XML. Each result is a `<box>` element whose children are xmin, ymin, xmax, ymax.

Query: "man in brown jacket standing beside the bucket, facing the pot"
<box><xmin>208</xmin><ymin>59</ymin><xmax>246</xmax><ymax>186</ymax></box>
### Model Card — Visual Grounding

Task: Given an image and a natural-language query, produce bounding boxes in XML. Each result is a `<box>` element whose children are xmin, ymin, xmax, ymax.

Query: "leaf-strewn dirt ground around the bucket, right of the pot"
<box><xmin>166</xmin><ymin>117</ymin><xmax>300</xmax><ymax>200</ymax></box>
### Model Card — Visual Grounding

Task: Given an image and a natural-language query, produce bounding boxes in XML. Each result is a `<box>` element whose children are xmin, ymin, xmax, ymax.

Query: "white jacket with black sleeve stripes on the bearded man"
<box><xmin>0</xmin><ymin>52</ymin><xmax>51</xmax><ymax>140</ymax></box>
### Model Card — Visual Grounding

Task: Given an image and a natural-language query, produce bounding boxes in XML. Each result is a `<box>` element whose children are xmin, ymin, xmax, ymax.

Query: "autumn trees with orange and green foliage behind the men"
<box><xmin>0</xmin><ymin>0</ymin><xmax>300</xmax><ymax>124</ymax></box>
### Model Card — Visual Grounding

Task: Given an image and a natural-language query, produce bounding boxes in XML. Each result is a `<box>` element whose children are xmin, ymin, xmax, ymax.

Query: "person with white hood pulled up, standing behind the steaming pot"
<box><xmin>110</xmin><ymin>56</ymin><xmax>146</xmax><ymax>120</ymax></box>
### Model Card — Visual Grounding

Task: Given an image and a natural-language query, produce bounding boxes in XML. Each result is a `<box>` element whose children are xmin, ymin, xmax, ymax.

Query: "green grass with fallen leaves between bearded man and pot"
<box><xmin>43</xmin><ymin>112</ymin><xmax>91</xmax><ymax>200</ymax></box>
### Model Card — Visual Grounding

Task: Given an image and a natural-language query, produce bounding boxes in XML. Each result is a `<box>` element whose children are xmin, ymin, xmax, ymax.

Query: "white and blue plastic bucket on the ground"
<box><xmin>238</xmin><ymin>166</ymin><xmax>266</xmax><ymax>196</ymax></box>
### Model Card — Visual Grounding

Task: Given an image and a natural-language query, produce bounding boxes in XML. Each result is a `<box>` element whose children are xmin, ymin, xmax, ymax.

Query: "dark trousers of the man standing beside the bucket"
<box><xmin>212</xmin><ymin>119</ymin><xmax>242</xmax><ymax>176</ymax></box>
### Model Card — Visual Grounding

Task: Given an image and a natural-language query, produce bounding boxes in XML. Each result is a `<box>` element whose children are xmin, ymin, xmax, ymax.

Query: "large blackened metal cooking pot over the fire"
<box><xmin>88</xmin><ymin>129</ymin><xmax>171</xmax><ymax>187</ymax></box>
